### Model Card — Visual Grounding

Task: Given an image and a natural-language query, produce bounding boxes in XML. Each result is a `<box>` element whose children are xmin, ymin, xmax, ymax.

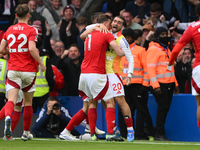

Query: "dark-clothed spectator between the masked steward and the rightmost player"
<box><xmin>175</xmin><ymin>48</ymin><xmax>192</xmax><ymax>93</ymax></box>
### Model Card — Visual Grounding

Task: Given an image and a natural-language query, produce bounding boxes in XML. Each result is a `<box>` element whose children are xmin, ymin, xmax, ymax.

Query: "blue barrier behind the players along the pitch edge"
<box><xmin>0</xmin><ymin>94</ymin><xmax>200</xmax><ymax>142</ymax></box>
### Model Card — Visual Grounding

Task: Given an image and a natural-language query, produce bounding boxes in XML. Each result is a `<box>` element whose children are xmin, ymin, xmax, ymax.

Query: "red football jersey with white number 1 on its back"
<box><xmin>81</xmin><ymin>31</ymin><xmax>115</xmax><ymax>74</ymax></box>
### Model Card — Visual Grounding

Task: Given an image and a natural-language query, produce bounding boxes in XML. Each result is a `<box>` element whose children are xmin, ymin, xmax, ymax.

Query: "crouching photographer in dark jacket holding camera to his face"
<box><xmin>32</xmin><ymin>96</ymin><xmax>86</xmax><ymax>138</ymax></box>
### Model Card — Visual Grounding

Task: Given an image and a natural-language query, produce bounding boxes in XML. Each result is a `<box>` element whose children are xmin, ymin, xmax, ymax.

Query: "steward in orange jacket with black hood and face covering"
<box><xmin>147</xmin><ymin>27</ymin><xmax>178</xmax><ymax>141</ymax></box>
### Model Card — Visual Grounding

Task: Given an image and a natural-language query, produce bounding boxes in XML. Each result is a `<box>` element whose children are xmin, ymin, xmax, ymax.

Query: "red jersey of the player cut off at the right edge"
<box><xmin>178</xmin><ymin>21</ymin><xmax>200</xmax><ymax>68</ymax></box>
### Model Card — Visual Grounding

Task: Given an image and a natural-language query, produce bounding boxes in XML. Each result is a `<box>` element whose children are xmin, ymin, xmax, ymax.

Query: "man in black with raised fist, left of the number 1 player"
<box><xmin>57</xmin><ymin>44</ymin><xmax>82</xmax><ymax>96</ymax></box>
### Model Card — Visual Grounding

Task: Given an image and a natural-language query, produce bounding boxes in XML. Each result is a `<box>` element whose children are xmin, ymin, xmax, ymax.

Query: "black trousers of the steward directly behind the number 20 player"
<box><xmin>118</xmin><ymin>84</ymin><xmax>154</xmax><ymax>138</ymax></box>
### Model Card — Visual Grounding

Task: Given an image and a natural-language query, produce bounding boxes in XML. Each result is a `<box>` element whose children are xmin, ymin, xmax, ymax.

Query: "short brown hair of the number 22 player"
<box><xmin>15</xmin><ymin>4</ymin><xmax>29</xmax><ymax>18</ymax></box>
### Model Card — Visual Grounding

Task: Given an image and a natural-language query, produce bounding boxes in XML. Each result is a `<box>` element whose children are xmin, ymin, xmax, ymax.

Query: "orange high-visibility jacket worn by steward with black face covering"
<box><xmin>147</xmin><ymin>42</ymin><xmax>178</xmax><ymax>89</ymax></box>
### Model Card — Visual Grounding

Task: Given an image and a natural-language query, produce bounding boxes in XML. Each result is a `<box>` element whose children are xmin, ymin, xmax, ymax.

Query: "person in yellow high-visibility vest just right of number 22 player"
<box><xmin>32</xmin><ymin>56</ymin><xmax>55</xmax><ymax>113</ymax></box>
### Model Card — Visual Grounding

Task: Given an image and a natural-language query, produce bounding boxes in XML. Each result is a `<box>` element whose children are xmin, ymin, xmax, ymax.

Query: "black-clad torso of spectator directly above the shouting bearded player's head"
<box><xmin>106</xmin><ymin>0</ymin><xmax>129</xmax><ymax>17</ymax></box>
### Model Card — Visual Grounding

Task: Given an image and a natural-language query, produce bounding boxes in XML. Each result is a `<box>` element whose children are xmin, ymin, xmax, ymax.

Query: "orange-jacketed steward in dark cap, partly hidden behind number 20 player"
<box><xmin>119</xmin><ymin>29</ymin><xmax>154</xmax><ymax>140</ymax></box>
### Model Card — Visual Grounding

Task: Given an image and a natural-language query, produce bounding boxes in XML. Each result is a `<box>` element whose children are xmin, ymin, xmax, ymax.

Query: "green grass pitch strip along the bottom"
<box><xmin>0</xmin><ymin>138</ymin><xmax>200</xmax><ymax>150</ymax></box>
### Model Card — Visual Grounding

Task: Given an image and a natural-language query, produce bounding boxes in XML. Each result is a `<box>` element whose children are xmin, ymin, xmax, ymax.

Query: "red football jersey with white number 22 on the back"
<box><xmin>3</xmin><ymin>23</ymin><xmax>38</xmax><ymax>72</ymax></box>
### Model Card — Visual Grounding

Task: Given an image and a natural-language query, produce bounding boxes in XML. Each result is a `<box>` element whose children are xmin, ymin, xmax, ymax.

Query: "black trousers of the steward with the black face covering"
<box><xmin>151</xmin><ymin>83</ymin><xmax>175</xmax><ymax>136</ymax></box>
